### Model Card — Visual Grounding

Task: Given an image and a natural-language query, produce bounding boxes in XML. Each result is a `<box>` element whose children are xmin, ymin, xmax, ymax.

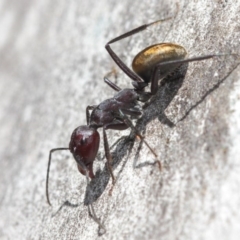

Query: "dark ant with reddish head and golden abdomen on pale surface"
<box><xmin>46</xmin><ymin>19</ymin><xmax>236</xmax><ymax>232</ymax></box>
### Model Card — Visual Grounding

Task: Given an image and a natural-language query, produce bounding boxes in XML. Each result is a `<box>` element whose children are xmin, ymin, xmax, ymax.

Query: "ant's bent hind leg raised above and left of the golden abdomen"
<box><xmin>105</xmin><ymin>17</ymin><xmax>171</xmax><ymax>82</ymax></box>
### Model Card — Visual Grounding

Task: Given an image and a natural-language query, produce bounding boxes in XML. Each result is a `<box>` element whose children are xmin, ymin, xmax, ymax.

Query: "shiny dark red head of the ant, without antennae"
<box><xmin>69</xmin><ymin>126</ymin><xmax>100</xmax><ymax>178</ymax></box>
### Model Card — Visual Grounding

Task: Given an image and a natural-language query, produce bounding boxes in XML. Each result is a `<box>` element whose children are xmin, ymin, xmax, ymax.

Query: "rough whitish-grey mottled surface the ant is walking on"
<box><xmin>0</xmin><ymin>0</ymin><xmax>240</xmax><ymax>240</ymax></box>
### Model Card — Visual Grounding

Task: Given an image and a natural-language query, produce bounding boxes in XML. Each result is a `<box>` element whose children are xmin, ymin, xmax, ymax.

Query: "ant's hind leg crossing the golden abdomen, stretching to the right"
<box><xmin>150</xmin><ymin>53</ymin><xmax>238</xmax><ymax>95</ymax></box>
